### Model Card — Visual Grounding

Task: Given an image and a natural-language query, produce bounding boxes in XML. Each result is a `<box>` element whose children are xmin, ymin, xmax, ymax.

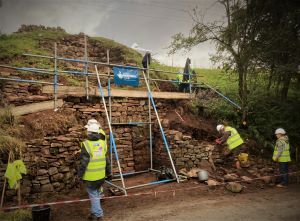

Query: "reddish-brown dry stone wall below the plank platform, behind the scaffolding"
<box><xmin>0</xmin><ymin>97</ymin><xmax>216</xmax><ymax>199</ymax></box>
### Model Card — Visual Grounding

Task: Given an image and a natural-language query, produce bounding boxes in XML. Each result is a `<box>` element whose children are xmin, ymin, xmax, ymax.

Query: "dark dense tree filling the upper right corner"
<box><xmin>249</xmin><ymin>0</ymin><xmax>300</xmax><ymax>100</ymax></box>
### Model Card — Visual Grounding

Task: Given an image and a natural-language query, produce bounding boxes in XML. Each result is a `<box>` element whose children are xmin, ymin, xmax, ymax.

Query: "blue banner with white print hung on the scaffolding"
<box><xmin>113</xmin><ymin>67</ymin><xmax>139</xmax><ymax>87</ymax></box>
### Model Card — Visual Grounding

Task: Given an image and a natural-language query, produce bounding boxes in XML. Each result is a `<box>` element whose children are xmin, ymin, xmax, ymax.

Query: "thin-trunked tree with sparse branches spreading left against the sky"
<box><xmin>170</xmin><ymin>0</ymin><xmax>257</xmax><ymax>121</ymax></box>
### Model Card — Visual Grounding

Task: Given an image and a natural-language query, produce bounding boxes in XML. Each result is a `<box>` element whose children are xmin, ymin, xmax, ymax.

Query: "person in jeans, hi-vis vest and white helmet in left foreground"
<box><xmin>78</xmin><ymin>119</ymin><xmax>111</xmax><ymax>221</ymax></box>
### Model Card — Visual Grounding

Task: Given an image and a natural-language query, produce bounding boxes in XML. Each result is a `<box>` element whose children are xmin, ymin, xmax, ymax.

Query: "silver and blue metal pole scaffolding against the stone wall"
<box><xmin>0</xmin><ymin>36</ymin><xmax>240</xmax><ymax>195</ymax></box>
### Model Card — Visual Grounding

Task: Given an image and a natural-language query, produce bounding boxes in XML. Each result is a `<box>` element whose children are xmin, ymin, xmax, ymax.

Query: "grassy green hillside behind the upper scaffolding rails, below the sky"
<box><xmin>0</xmin><ymin>25</ymin><xmax>227</xmax><ymax>91</ymax></box>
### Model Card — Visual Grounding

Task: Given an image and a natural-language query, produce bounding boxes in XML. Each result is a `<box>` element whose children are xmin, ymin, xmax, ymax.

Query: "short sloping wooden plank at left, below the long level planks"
<box><xmin>0</xmin><ymin>99</ymin><xmax>64</xmax><ymax>116</ymax></box>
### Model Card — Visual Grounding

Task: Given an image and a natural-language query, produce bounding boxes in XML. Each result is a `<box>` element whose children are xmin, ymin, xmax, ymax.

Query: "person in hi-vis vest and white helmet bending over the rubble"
<box><xmin>216</xmin><ymin>124</ymin><xmax>247</xmax><ymax>169</ymax></box>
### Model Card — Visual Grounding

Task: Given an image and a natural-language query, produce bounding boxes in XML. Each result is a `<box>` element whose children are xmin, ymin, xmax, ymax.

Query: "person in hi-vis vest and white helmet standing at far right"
<box><xmin>273</xmin><ymin>128</ymin><xmax>291</xmax><ymax>187</ymax></box>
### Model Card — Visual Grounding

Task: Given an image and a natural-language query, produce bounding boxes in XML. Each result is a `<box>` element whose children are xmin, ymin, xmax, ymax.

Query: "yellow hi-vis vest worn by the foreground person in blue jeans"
<box><xmin>82</xmin><ymin>140</ymin><xmax>107</xmax><ymax>181</ymax></box>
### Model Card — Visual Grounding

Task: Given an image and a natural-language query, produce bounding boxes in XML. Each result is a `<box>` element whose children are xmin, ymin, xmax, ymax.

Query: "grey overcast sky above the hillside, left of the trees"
<box><xmin>0</xmin><ymin>0</ymin><xmax>223</xmax><ymax>68</ymax></box>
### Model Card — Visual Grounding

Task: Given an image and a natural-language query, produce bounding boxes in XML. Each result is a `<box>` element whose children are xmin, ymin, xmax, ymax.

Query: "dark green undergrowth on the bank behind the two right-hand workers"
<box><xmin>194</xmin><ymin>95</ymin><xmax>300</xmax><ymax>159</ymax></box>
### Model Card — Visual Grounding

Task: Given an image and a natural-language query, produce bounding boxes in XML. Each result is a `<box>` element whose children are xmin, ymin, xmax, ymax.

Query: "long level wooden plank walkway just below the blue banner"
<box><xmin>42</xmin><ymin>86</ymin><xmax>191</xmax><ymax>99</ymax></box>
